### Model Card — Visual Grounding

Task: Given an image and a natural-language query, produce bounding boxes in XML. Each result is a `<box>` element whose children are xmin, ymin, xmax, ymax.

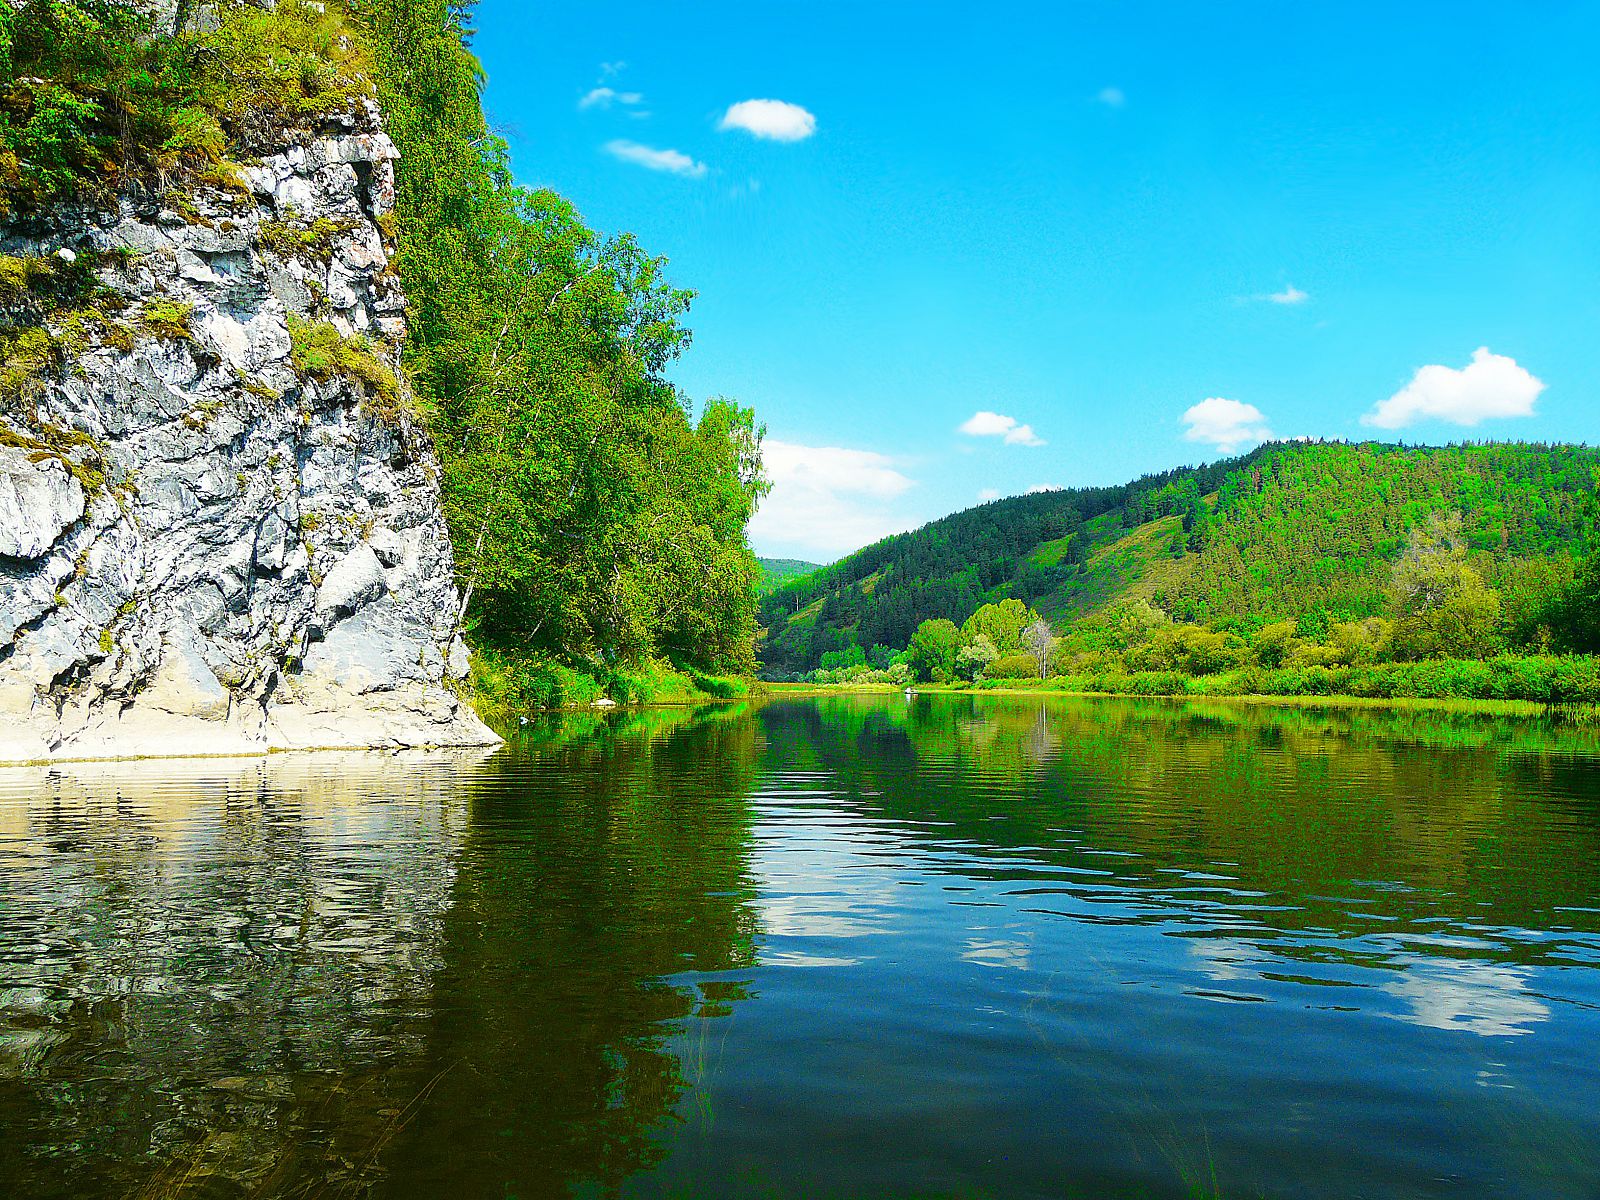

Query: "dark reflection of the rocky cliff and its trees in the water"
<box><xmin>0</xmin><ymin>710</ymin><xmax>754</xmax><ymax>1200</ymax></box>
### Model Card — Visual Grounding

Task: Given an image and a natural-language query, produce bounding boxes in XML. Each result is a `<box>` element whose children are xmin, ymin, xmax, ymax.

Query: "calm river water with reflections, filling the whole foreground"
<box><xmin>0</xmin><ymin>696</ymin><xmax>1600</xmax><ymax>1200</ymax></box>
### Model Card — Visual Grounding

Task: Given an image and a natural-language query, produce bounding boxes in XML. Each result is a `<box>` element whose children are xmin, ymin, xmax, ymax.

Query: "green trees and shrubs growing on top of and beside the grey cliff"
<box><xmin>0</xmin><ymin>0</ymin><xmax>766</xmax><ymax>709</ymax></box>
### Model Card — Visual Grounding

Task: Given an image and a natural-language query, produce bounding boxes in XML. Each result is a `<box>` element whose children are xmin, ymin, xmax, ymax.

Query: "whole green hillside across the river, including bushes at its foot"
<box><xmin>762</xmin><ymin>443</ymin><xmax>1600</xmax><ymax>700</ymax></box>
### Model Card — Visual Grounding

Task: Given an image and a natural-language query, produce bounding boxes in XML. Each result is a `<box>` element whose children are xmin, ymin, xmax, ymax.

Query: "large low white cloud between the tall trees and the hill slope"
<box><xmin>750</xmin><ymin>438</ymin><xmax>917</xmax><ymax>558</ymax></box>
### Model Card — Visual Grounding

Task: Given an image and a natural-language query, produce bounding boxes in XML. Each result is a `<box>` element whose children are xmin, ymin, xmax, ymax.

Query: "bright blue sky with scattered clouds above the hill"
<box><xmin>477</xmin><ymin>0</ymin><xmax>1600</xmax><ymax>560</ymax></box>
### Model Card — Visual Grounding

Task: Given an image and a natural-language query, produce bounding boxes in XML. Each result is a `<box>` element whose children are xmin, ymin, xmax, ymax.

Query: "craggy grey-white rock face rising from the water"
<box><xmin>0</xmin><ymin>107</ymin><xmax>498</xmax><ymax>762</ymax></box>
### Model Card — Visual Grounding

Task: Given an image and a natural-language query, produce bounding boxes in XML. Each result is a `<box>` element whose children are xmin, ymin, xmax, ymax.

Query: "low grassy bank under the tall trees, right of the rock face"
<box><xmin>466</xmin><ymin>646</ymin><xmax>752</xmax><ymax>725</ymax></box>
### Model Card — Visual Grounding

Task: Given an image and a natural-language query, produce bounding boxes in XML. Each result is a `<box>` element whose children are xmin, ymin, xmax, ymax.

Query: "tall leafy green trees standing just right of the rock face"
<box><xmin>363</xmin><ymin>0</ymin><xmax>766</xmax><ymax>670</ymax></box>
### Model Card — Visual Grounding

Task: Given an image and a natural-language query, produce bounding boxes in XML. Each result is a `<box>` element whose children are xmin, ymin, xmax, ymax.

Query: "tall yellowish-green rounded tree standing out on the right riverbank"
<box><xmin>1390</xmin><ymin>512</ymin><xmax>1499</xmax><ymax>659</ymax></box>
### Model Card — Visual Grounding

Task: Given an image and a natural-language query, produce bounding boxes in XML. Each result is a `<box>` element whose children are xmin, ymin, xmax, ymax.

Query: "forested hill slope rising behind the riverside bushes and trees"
<box><xmin>762</xmin><ymin>443</ymin><xmax>1600</xmax><ymax>677</ymax></box>
